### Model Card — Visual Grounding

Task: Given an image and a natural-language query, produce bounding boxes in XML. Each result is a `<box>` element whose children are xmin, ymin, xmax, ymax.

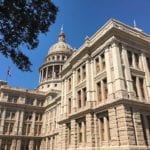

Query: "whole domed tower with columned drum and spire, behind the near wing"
<box><xmin>38</xmin><ymin>28</ymin><xmax>73</xmax><ymax>91</ymax></box>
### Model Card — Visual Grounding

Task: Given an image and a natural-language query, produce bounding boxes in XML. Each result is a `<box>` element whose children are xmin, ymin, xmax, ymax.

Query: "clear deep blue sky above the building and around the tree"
<box><xmin>0</xmin><ymin>0</ymin><xmax>150</xmax><ymax>89</ymax></box>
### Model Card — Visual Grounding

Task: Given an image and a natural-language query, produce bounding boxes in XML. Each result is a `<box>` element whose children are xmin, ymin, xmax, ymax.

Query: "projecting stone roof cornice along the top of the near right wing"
<box><xmin>62</xmin><ymin>19</ymin><xmax>150</xmax><ymax>72</ymax></box>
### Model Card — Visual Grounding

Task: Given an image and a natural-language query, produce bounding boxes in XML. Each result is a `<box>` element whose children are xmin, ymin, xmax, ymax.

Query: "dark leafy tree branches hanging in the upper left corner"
<box><xmin>0</xmin><ymin>0</ymin><xmax>58</xmax><ymax>71</ymax></box>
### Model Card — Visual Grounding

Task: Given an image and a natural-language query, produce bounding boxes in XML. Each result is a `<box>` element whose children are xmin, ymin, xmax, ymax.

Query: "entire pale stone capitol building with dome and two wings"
<box><xmin>0</xmin><ymin>19</ymin><xmax>150</xmax><ymax>150</ymax></box>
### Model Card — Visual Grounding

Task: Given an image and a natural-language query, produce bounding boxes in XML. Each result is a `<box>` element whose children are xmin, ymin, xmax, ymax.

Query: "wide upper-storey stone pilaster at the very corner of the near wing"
<box><xmin>111</xmin><ymin>43</ymin><xmax>125</xmax><ymax>98</ymax></box>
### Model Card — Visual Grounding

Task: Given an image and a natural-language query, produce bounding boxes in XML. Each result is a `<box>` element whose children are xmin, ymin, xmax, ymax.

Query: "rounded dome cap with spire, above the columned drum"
<box><xmin>48</xmin><ymin>29</ymin><xmax>72</xmax><ymax>54</ymax></box>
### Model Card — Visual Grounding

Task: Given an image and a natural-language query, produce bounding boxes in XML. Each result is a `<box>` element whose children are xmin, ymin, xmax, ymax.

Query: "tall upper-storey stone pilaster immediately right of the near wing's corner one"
<box><xmin>122</xmin><ymin>46</ymin><xmax>135</xmax><ymax>98</ymax></box>
